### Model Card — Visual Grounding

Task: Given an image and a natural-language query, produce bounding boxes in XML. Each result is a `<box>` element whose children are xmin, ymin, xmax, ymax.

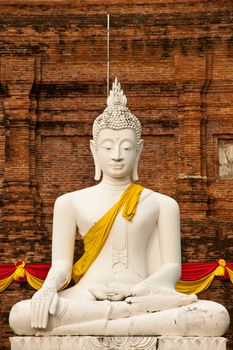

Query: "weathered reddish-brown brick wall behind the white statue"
<box><xmin>0</xmin><ymin>0</ymin><xmax>233</xmax><ymax>349</ymax></box>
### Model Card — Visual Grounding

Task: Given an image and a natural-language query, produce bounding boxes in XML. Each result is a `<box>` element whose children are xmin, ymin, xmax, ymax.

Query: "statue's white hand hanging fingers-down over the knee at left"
<box><xmin>31</xmin><ymin>286</ymin><xmax>59</xmax><ymax>328</ymax></box>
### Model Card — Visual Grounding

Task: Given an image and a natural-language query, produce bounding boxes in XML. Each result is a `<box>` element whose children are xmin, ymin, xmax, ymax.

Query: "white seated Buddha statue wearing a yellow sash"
<box><xmin>10</xmin><ymin>79</ymin><xmax>229</xmax><ymax>336</ymax></box>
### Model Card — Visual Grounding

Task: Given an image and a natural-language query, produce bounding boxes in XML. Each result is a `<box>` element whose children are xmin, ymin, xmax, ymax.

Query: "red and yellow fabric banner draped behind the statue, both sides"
<box><xmin>0</xmin><ymin>259</ymin><xmax>233</xmax><ymax>294</ymax></box>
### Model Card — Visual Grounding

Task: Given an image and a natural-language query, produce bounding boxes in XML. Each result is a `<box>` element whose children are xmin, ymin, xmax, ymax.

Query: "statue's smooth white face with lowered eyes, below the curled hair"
<box><xmin>91</xmin><ymin>129</ymin><xmax>142</xmax><ymax>179</ymax></box>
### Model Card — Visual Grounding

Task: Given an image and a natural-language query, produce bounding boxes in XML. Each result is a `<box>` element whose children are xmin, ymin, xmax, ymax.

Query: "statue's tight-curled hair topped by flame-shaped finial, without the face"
<box><xmin>92</xmin><ymin>78</ymin><xmax>141</xmax><ymax>144</ymax></box>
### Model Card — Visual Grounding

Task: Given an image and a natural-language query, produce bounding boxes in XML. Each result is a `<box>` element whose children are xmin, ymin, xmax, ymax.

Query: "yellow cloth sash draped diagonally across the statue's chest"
<box><xmin>73</xmin><ymin>183</ymin><xmax>144</xmax><ymax>283</ymax></box>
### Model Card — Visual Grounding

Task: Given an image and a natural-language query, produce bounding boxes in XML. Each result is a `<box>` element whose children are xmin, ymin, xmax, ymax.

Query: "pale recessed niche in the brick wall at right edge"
<box><xmin>218</xmin><ymin>139</ymin><xmax>233</xmax><ymax>179</ymax></box>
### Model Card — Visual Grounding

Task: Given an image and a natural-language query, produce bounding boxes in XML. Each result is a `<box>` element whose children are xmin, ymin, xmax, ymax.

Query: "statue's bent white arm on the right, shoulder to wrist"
<box><xmin>132</xmin><ymin>196</ymin><xmax>181</xmax><ymax>295</ymax></box>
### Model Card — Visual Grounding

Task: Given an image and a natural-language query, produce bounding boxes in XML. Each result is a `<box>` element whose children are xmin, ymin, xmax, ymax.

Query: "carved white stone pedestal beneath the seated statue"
<box><xmin>10</xmin><ymin>336</ymin><xmax>226</xmax><ymax>350</ymax></box>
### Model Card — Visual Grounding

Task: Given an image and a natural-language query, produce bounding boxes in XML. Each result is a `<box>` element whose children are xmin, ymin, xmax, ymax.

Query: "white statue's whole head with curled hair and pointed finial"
<box><xmin>90</xmin><ymin>78</ymin><xmax>143</xmax><ymax>181</ymax></box>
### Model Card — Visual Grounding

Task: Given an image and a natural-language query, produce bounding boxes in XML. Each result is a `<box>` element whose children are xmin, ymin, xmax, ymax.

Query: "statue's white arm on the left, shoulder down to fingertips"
<box><xmin>31</xmin><ymin>195</ymin><xmax>76</xmax><ymax>328</ymax></box>
